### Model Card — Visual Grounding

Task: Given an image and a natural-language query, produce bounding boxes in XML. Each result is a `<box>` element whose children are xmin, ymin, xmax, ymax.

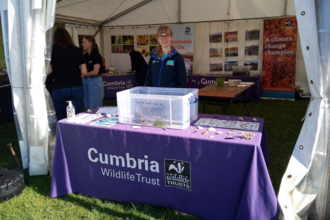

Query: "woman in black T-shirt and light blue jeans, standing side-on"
<box><xmin>81</xmin><ymin>36</ymin><xmax>104</xmax><ymax>109</ymax></box>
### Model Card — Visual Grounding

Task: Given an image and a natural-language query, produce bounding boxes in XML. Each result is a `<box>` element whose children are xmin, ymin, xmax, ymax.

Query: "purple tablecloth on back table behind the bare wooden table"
<box><xmin>187</xmin><ymin>75</ymin><xmax>262</xmax><ymax>103</ymax></box>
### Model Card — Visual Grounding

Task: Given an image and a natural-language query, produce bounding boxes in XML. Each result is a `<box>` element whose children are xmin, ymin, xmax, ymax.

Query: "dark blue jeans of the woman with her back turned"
<box><xmin>52</xmin><ymin>86</ymin><xmax>84</xmax><ymax>121</ymax></box>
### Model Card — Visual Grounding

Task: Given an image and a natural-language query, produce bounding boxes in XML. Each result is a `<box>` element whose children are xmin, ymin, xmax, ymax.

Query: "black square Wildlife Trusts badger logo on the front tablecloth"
<box><xmin>164</xmin><ymin>159</ymin><xmax>191</xmax><ymax>191</ymax></box>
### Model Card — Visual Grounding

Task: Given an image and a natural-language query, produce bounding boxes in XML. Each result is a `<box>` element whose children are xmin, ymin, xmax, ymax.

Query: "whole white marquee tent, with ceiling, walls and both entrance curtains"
<box><xmin>0</xmin><ymin>0</ymin><xmax>330</xmax><ymax>219</ymax></box>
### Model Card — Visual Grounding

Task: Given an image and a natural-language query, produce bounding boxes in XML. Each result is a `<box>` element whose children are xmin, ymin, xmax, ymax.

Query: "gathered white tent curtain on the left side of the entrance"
<box><xmin>0</xmin><ymin>0</ymin><xmax>56</xmax><ymax>175</ymax></box>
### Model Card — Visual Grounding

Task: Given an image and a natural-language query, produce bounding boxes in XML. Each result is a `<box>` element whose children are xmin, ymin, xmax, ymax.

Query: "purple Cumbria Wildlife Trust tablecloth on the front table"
<box><xmin>50</xmin><ymin>114</ymin><xmax>279</xmax><ymax>220</ymax></box>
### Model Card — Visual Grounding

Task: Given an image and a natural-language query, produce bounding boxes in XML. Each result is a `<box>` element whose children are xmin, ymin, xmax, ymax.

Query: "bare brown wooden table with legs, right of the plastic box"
<box><xmin>199</xmin><ymin>83</ymin><xmax>255</xmax><ymax>115</ymax></box>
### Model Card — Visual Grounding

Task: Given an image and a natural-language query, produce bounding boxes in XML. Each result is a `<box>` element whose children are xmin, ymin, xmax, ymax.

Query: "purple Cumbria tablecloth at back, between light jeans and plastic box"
<box><xmin>102</xmin><ymin>74</ymin><xmax>140</xmax><ymax>99</ymax></box>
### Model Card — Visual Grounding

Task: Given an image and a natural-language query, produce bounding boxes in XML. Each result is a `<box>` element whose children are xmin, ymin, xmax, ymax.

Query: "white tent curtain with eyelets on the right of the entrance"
<box><xmin>278</xmin><ymin>0</ymin><xmax>330</xmax><ymax>220</ymax></box>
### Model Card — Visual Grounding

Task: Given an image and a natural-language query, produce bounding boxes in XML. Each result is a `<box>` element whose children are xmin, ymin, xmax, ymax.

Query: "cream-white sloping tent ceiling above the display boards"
<box><xmin>56</xmin><ymin>0</ymin><xmax>296</xmax><ymax>26</ymax></box>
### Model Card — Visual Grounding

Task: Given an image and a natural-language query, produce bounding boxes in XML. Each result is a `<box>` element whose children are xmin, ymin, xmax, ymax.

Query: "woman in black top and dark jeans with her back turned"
<box><xmin>48</xmin><ymin>28</ymin><xmax>87</xmax><ymax>120</ymax></box>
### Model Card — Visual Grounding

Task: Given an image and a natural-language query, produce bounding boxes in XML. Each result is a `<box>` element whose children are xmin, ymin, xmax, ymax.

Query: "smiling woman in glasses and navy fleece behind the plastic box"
<box><xmin>146</xmin><ymin>25</ymin><xmax>187</xmax><ymax>88</ymax></box>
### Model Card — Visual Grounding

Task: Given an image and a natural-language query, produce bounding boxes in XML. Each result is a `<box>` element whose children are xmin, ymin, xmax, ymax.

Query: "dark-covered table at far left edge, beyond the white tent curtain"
<box><xmin>0</xmin><ymin>85</ymin><xmax>14</xmax><ymax>123</ymax></box>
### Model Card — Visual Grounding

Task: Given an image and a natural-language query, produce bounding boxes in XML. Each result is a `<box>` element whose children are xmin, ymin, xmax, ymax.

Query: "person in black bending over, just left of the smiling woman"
<box><xmin>128</xmin><ymin>47</ymin><xmax>148</xmax><ymax>86</ymax></box>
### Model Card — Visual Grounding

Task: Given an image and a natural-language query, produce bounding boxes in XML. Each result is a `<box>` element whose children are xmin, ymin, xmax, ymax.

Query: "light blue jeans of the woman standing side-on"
<box><xmin>83</xmin><ymin>77</ymin><xmax>104</xmax><ymax>111</ymax></box>
